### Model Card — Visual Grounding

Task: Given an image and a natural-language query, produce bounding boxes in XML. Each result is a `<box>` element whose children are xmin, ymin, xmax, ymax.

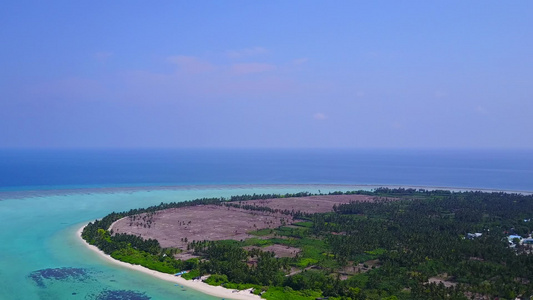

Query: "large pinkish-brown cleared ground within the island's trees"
<box><xmin>110</xmin><ymin>195</ymin><xmax>380</xmax><ymax>253</ymax></box>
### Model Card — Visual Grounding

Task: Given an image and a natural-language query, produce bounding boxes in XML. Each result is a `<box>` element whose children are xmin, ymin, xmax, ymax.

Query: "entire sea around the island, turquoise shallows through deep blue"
<box><xmin>0</xmin><ymin>150</ymin><xmax>533</xmax><ymax>300</ymax></box>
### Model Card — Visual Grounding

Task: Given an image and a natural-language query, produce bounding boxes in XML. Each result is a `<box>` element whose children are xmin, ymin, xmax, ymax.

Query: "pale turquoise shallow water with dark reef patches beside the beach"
<box><xmin>0</xmin><ymin>185</ymin><xmax>362</xmax><ymax>300</ymax></box>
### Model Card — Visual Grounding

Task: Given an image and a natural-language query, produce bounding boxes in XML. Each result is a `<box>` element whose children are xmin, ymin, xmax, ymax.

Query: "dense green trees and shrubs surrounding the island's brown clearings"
<box><xmin>82</xmin><ymin>188</ymin><xmax>533</xmax><ymax>299</ymax></box>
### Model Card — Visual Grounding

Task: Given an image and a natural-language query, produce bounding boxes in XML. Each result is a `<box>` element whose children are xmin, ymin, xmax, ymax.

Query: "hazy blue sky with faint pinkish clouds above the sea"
<box><xmin>0</xmin><ymin>1</ymin><xmax>533</xmax><ymax>148</ymax></box>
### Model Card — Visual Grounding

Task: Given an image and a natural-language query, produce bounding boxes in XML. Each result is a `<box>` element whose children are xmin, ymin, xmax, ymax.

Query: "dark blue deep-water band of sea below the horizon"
<box><xmin>0</xmin><ymin>149</ymin><xmax>533</xmax><ymax>191</ymax></box>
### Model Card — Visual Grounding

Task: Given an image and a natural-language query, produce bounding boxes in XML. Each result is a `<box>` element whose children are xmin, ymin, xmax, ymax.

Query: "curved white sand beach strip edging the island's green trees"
<box><xmin>76</xmin><ymin>225</ymin><xmax>263</xmax><ymax>300</ymax></box>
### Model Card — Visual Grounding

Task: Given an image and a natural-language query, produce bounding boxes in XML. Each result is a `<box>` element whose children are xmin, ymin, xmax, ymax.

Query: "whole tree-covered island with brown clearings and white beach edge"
<box><xmin>79</xmin><ymin>188</ymin><xmax>533</xmax><ymax>300</ymax></box>
